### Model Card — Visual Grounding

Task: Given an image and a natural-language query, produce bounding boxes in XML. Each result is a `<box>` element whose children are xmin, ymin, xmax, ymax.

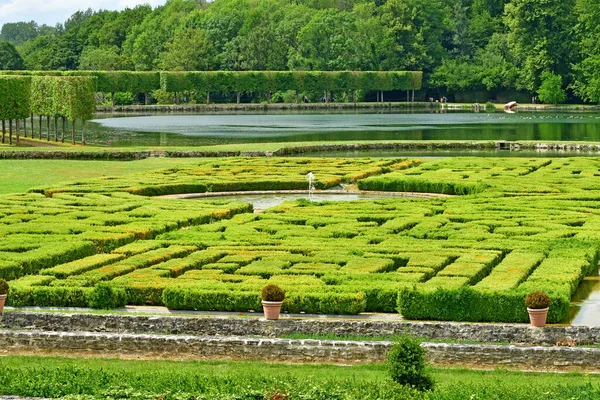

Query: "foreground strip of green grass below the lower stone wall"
<box><xmin>0</xmin><ymin>356</ymin><xmax>600</xmax><ymax>400</ymax></box>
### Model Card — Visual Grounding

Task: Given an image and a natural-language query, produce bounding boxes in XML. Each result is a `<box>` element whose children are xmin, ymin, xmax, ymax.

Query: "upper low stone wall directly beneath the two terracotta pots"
<box><xmin>0</xmin><ymin>312</ymin><xmax>600</xmax><ymax>345</ymax></box>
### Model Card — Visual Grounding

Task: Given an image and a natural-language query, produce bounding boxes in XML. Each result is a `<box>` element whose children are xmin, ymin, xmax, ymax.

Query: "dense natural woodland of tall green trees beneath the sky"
<box><xmin>0</xmin><ymin>0</ymin><xmax>600</xmax><ymax>103</ymax></box>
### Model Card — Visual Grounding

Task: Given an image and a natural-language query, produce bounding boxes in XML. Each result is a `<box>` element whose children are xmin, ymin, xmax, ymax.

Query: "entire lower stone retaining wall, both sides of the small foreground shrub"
<box><xmin>0</xmin><ymin>330</ymin><xmax>600</xmax><ymax>371</ymax></box>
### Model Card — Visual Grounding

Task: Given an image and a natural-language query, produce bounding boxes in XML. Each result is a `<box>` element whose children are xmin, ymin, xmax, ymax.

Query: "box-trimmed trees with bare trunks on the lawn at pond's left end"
<box><xmin>0</xmin><ymin>76</ymin><xmax>96</xmax><ymax>144</ymax></box>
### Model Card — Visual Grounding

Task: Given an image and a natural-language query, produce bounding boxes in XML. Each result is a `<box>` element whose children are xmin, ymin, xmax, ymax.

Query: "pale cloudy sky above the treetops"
<box><xmin>0</xmin><ymin>0</ymin><xmax>165</xmax><ymax>26</ymax></box>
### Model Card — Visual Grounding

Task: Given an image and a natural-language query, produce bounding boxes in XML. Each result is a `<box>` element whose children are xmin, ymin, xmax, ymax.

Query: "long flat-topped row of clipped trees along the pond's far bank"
<box><xmin>0</xmin><ymin>71</ymin><xmax>423</xmax><ymax>106</ymax></box>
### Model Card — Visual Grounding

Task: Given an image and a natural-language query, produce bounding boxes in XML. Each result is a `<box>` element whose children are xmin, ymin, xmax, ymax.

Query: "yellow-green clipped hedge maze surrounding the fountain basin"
<box><xmin>0</xmin><ymin>158</ymin><xmax>600</xmax><ymax>322</ymax></box>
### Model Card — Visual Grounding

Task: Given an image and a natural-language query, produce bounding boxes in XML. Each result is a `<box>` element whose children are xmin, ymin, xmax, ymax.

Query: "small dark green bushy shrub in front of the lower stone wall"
<box><xmin>387</xmin><ymin>335</ymin><xmax>433</xmax><ymax>391</ymax></box>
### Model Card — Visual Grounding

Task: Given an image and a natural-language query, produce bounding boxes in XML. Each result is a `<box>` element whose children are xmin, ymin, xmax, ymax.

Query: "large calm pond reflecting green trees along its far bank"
<box><xmin>87</xmin><ymin>111</ymin><xmax>600</xmax><ymax>146</ymax></box>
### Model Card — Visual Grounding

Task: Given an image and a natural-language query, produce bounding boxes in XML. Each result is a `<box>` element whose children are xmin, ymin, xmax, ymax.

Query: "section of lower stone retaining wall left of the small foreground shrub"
<box><xmin>0</xmin><ymin>331</ymin><xmax>390</xmax><ymax>364</ymax></box>
